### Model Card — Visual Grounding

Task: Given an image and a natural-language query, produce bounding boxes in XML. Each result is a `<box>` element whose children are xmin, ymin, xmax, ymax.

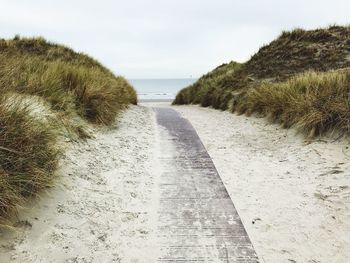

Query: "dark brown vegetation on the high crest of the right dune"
<box><xmin>243</xmin><ymin>26</ymin><xmax>350</xmax><ymax>81</ymax></box>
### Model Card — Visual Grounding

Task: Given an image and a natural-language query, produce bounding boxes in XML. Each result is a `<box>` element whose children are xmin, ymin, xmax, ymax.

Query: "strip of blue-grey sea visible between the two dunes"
<box><xmin>129</xmin><ymin>79</ymin><xmax>197</xmax><ymax>101</ymax></box>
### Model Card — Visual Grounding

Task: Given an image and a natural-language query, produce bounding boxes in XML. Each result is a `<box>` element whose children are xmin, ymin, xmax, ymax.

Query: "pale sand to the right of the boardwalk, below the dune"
<box><xmin>174</xmin><ymin>105</ymin><xmax>350</xmax><ymax>263</ymax></box>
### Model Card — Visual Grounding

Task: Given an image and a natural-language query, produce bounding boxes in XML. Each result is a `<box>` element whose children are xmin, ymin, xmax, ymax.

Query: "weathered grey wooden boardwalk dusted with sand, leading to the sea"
<box><xmin>155</xmin><ymin>108</ymin><xmax>258</xmax><ymax>263</ymax></box>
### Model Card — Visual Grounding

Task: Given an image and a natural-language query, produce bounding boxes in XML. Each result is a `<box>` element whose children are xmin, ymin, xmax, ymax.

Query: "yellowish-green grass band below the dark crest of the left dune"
<box><xmin>0</xmin><ymin>47</ymin><xmax>137</xmax><ymax>125</ymax></box>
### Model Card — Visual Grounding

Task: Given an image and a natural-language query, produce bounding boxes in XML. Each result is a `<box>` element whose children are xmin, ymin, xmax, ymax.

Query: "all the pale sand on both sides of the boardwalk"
<box><xmin>0</xmin><ymin>102</ymin><xmax>350</xmax><ymax>262</ymax></box>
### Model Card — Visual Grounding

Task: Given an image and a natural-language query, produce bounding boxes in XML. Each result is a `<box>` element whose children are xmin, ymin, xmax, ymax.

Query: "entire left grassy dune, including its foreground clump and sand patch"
<box><xmin>0</xmin><ymin>37</ymin><xmax>137</xmax><ymax>221</ymax></box>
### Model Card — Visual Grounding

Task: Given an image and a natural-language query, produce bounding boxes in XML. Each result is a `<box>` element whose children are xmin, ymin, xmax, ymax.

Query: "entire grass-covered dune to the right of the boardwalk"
<box><xmin>174</xmin><ymin>26</ymin><xmax>350</xmax><ymax>136</ymax></box>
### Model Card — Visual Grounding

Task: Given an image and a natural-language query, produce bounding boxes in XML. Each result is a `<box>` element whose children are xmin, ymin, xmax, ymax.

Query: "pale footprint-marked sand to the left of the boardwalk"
<box><xmin>0</xmin><ymin>106</ymin><xmax>159</xmax><ymax>263</ymax></box>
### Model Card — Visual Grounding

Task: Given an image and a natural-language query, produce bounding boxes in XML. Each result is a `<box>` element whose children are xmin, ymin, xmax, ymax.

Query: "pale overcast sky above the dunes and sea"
<box><xmin>0</xmin><ymin>0</ymin><xmax>350</xmax><ymax>79</ymax></box>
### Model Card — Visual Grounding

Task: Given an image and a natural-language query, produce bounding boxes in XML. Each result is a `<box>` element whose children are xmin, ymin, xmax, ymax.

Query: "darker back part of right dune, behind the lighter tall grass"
<box><xmin>174</xmin><ymin>26</ymin><xmax>350</xmax><ymax>110</ymax></box>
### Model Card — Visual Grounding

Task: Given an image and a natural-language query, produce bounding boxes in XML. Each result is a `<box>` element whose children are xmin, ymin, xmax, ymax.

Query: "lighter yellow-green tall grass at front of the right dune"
<box><xmin>234</xmin><ymin>69</ymin><xmax>350</xmax><ymax>136</ymax></box>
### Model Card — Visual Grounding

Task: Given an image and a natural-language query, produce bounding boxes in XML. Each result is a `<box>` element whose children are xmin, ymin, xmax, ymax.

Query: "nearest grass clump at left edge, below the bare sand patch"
<box><xmin>0</xmin><ymin>96</ymin><xmax>60</xmax><ymax>220</ymax></box>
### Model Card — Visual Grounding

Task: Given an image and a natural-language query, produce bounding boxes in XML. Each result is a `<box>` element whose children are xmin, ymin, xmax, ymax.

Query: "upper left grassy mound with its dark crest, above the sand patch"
<box><xmin>0</xmin><ymin>38</ymin><xmax>137</xmax><ymax>124</ymax></box>
